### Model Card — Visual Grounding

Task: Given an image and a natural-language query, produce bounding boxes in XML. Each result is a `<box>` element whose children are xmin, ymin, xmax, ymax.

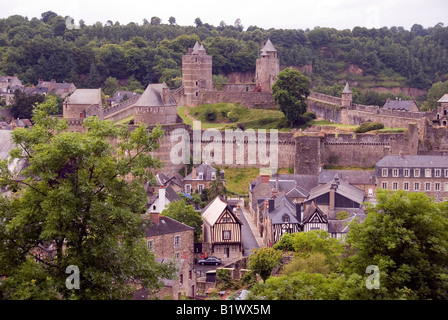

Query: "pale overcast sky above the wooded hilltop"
<box><xmin>0</xmin><ymin>0</ymin><xmax>448</xmax><ymax>30</ymax></box>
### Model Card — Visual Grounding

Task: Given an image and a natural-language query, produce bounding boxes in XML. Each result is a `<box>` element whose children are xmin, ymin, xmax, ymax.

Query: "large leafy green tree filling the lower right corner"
<box><xmin>344</xmin><ymin>190</ymin><xmax>448</xmax><ymax>299</ymax></box>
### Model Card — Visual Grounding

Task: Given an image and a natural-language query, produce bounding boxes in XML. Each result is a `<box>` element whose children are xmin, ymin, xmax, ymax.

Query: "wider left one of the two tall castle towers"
<box><xmin>182</xmin><ymin>42</ymin><xmax>213</xmax><ymax>106</ymax></box>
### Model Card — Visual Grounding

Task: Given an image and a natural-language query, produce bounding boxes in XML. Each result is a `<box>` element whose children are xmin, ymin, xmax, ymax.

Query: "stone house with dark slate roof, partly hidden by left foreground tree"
<box><xmin>139</xmin><ymin>213</ymin><xmax>197</xmax><ymax>300</ymax></box>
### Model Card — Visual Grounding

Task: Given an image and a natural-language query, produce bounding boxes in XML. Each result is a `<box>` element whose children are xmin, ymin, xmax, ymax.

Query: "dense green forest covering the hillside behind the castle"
<box><xmin>0</xmin><ymin>11</ymin><xmax>448</xmax><ymax>94</ymax></box>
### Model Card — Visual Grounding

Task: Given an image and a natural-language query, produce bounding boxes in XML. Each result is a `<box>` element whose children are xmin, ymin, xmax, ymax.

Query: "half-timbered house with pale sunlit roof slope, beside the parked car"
<box><xmin>201</xmin><ymin>196</ymin><xmax>243</xmax><ymax>258</ymax></box>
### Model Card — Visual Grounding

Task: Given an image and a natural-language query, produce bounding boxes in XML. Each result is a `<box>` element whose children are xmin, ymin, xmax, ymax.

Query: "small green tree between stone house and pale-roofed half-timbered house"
<box><xmin>161</xmin><ymin>198</ymin><xmax>202</xmax><ymax>241</ymax></box>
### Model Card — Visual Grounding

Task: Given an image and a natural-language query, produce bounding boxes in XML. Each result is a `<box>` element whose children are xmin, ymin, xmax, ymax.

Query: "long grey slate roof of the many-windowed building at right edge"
<box><xmin>376</xmin><ymin>155</ymin><xmax>448</xmax><ymax>168</ymax></box>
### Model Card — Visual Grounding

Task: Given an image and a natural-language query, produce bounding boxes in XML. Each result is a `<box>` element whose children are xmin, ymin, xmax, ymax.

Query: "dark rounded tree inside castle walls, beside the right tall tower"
<box><xmin>272</xmin><ymin>68</ymin><xmax>311</xmax><ymax>127</ymax></box>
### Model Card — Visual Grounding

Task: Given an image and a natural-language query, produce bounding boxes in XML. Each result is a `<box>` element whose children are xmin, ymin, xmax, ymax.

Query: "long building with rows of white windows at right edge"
<box><xmin>375</xmin><ymin>153</ymin><xmax>448</xmax><ymax>201</ymax></box>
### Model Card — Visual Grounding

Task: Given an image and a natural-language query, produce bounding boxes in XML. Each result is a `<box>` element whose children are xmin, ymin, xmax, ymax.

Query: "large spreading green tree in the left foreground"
<box><xmin>0</xmin><ymin>96</ymin><xmax>173</xmax><ymax>299</ymax></box>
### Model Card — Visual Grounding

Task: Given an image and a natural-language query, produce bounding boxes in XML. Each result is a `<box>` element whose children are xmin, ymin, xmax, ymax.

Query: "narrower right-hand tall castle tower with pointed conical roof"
<box><xmin>255</xmin><ymin>39</ymin><xmax>280</xmax><ymax>92</ymax></box>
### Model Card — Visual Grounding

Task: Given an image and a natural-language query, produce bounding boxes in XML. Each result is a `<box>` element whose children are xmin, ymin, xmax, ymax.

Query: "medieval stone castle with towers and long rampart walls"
<box><xmin>64</xmin><ymin>40</ymin><xmax>448</xmax><ymax>178</ymax></box>
